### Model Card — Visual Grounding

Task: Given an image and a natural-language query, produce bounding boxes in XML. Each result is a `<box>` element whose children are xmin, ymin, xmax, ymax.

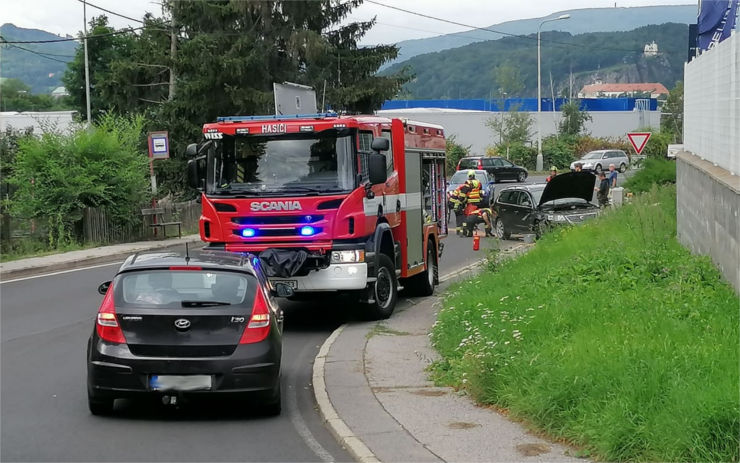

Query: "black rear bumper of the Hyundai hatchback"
<box><xmin>87</xmin><ymin>336</ymin><xmax>281</xmax><ymax>398</ymax></box>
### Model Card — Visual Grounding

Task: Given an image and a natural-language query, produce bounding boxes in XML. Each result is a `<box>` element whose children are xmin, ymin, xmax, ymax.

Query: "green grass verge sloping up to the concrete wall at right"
<box><xmin>432</xmin><ymin>186</ymin><xmax>740</xmax><ymax>461</ymax></box>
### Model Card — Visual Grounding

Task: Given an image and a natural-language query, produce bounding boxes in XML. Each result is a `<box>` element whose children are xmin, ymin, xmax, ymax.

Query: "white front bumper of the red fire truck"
<box><xmin>270</xmin><ymin>262</ymin><xmax>368</xmax><ymax>292</ymax></box>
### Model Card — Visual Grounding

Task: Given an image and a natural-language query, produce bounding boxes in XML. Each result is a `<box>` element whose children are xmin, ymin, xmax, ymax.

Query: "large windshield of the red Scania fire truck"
<box><xmin>208</xmin><ymin>130</ymin><xmax>357</xmax><ymax>196</ymax></box>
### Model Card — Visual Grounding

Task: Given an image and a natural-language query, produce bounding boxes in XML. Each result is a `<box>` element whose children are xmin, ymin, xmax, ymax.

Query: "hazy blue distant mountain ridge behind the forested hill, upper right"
<box><xmin>381</xmin><ymin>5</ymin><xmax>697</xmax><ymax>69</ymax></box>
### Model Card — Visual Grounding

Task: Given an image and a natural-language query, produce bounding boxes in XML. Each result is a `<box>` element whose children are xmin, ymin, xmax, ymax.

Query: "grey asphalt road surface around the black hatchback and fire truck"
<box><xmin>0</xmin><ymin>230</ymin><xmax>502</xmax><ymax>461</ymax></box>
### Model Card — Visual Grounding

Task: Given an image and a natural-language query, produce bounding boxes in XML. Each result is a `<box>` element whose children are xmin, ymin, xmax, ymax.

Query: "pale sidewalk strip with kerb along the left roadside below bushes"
<box><xmin>0</xmin><ymin>235</ymin><xmax>201</xmax><ymax>281</ymax></box>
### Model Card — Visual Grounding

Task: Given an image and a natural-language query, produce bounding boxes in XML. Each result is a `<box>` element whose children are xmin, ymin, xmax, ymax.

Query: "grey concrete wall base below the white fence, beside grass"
<box><xmin>676</xmin><ymin>152</ymin><xmax>740</xmax><ymax>294</ymax></box>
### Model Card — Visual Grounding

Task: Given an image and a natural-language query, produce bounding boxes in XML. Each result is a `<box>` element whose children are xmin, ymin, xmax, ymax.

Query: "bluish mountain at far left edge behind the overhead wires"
<box><xmin>0</xmin><ymin>23</ymin><xmax>78</xmax><ymax>93</ymax></box>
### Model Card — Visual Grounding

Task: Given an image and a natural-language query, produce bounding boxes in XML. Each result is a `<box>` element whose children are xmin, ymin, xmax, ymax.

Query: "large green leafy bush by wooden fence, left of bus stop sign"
<box><xmin>9</xmin><ymin>115</ymin><xmax>149</xmax><ymax>248</ymax></box>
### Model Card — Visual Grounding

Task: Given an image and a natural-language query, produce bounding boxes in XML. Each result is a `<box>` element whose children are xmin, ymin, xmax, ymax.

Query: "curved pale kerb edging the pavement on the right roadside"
<box><xmin>313</xmin><ymin>323</ymin><xmax>380</xmax><ymax>463</ymax></box>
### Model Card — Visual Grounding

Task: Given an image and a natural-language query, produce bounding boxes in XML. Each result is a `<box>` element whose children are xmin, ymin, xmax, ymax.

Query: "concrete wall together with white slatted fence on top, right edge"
<box><xmin>676</xmin><ymin>34</ymin><xmax>740</xmax><ymax>294</ymax></box>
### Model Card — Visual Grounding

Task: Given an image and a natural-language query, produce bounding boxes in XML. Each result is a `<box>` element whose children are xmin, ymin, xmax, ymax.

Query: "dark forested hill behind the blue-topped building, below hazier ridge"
<box><xmin>385</xmin><ymin>23</ymin><xmax>688</xmax><ymax>99</ymax></box>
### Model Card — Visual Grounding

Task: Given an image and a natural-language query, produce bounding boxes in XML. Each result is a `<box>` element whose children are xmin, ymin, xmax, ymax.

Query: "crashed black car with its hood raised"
<box><xmin>493</xmin><ymin>172</ymin><xmax>599</xmax><ymax>239</ymax></box>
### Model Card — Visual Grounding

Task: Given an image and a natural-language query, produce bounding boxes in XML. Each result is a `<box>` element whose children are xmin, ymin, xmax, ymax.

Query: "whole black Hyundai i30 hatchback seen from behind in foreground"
<box><xmin>87</xmin><ymin>252</ymin><xmax>284</xmax><ymax>415</ymax></box>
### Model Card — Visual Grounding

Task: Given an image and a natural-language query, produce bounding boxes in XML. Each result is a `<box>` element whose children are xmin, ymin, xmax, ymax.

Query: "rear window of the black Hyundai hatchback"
<box><xmin>115</xmin><ymin>270</ymin><xmax>257</xmax><ymax>308</ymax></box>
